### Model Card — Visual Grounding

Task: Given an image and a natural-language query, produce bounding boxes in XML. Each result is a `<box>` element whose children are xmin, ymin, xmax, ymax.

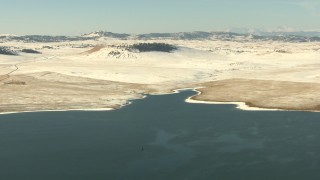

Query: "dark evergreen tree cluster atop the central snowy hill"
<box><xmin>130</xmin><ymin>43</ymin><xmax>178</xmax><ymax>53</ymax></box>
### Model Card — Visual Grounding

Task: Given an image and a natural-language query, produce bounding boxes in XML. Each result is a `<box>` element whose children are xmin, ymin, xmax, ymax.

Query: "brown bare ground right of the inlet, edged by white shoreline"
<box><xmin>193</xmin><ymin>79</ymin><xmax>320</xmax><ymax>111</ymax></box>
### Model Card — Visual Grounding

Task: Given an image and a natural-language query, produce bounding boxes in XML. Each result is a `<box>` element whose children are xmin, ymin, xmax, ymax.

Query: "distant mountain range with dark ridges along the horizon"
<box><xmin>0</xmin><ymin>30</ymin><xmax>320</xmax><ymax>42</ymax></box>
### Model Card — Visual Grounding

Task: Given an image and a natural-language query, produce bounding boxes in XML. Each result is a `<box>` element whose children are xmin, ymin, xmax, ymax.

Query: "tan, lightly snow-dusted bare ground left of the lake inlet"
<box><xmin>0</xmin><ymin>72</ymin><xmax>162</xmax><ymax>113</ymax></box>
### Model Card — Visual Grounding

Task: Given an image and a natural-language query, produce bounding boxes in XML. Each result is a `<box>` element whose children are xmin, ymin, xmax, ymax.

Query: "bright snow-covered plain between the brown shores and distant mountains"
<box><xmin>0</xmin><ymin>35</ymin><xmax>320</xmax><ymax>111</ymax></box>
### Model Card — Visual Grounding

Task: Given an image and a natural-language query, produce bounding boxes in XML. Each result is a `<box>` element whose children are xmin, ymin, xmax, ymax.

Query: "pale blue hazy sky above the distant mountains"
<box><xmin>0</xmin><ymin>0</ymin><xmax>320</xmax><ymax>35</ymax></box>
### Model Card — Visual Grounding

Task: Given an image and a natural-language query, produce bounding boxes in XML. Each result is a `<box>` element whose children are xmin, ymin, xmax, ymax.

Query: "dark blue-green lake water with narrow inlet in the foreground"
<box><xmin>0</xmin><ymin>91</ymin><xmax>320</xmax><ymax>180</ymax></box>
